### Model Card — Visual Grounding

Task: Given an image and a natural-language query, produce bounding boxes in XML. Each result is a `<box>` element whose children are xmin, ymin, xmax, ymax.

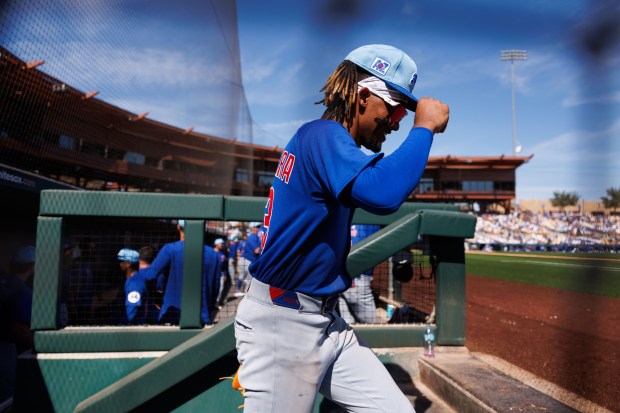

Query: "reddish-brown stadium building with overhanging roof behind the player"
<box><xmin>0</xmin><ymin>49</ymin><xmax>531</xmax><ymax>212</ymax></box>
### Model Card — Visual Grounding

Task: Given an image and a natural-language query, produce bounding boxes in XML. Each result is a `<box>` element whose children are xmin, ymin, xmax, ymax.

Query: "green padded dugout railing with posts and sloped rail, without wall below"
<box><xmin>26</xmin><ymin>190</ymin><xmax>476</xmax><ymax>412</ymax></box>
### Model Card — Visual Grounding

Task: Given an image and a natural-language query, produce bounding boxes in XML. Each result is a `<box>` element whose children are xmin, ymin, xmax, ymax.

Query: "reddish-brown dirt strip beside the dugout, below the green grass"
<box><xmin>466</xmin><ymin>275</ymin><xmax>620</xmax><ymax>412</ymax></box>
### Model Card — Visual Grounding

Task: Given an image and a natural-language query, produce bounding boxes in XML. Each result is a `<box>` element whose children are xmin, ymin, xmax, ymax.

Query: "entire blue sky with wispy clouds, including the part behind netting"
<box><xmin>0</xmin><ymin>0</ymin><xmax>620</xmax><ymax>200</ymax></box>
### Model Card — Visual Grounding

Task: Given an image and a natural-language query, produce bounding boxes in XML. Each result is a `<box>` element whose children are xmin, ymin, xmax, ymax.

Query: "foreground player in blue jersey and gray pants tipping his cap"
<box><xmin>235</xmin><ymin>45</ymin><xmax>449</xmax><ymax>413</ymax></box>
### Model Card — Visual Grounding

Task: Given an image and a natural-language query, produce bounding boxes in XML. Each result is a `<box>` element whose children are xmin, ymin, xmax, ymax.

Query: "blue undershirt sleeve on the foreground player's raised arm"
<box><xmin>350</xmin><ymin>128</ymin><xmax>433</xmax><ymax>215</ymax></box>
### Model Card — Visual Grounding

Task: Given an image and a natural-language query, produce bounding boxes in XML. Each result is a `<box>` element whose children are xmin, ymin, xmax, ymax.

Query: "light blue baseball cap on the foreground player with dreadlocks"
<box><xmin>345</xmin><ymin>44</ymin><xmax>418</xmax><ymax>112</ymax></box>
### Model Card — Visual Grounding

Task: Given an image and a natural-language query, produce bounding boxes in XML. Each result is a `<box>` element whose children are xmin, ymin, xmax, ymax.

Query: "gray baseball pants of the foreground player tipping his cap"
<box><xmin>235</xmin><ymin>279</ymin><xmax>415</xmax><ymax>413</ymax></box>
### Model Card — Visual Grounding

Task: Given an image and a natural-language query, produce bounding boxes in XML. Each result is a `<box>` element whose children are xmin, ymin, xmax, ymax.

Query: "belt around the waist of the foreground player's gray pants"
<box><xmin>246</xmin><ymin>278</ymin><xmax>338</xmax><ymax>314</ymax></box>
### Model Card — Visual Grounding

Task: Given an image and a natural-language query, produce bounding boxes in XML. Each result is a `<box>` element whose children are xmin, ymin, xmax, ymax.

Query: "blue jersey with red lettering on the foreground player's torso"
<box><xmin>250</xmin><ymin>120</ymin><xmax>383</xmax><ymax>296</ymax></box>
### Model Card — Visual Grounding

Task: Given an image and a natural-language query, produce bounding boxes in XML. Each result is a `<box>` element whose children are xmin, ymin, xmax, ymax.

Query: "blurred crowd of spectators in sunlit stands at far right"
<box><xmin>467</xmin><ymin>211</ymin><xmax>620</xmax><ymax>252</ymax></box>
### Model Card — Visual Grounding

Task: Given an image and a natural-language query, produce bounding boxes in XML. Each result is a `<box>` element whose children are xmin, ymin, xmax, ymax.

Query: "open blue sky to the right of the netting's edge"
<box><xmin>237</xmin><ymin>0</ymin><xmax>620</xmax><ymax>200</ymax></box>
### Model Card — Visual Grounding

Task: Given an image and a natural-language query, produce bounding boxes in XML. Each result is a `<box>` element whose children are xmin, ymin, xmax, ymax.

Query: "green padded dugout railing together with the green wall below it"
<box><xmin>15</xmin><ymin>190</ymin><xmax>476</xmax><ymax>412</ymax></box>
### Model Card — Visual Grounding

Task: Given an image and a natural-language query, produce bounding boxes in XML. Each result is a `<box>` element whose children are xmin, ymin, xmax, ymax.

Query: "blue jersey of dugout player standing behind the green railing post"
<box><xmin>144</xmin><ymin>241</ymin><xmax>221</xmax><ymax>324</ymax></box>
